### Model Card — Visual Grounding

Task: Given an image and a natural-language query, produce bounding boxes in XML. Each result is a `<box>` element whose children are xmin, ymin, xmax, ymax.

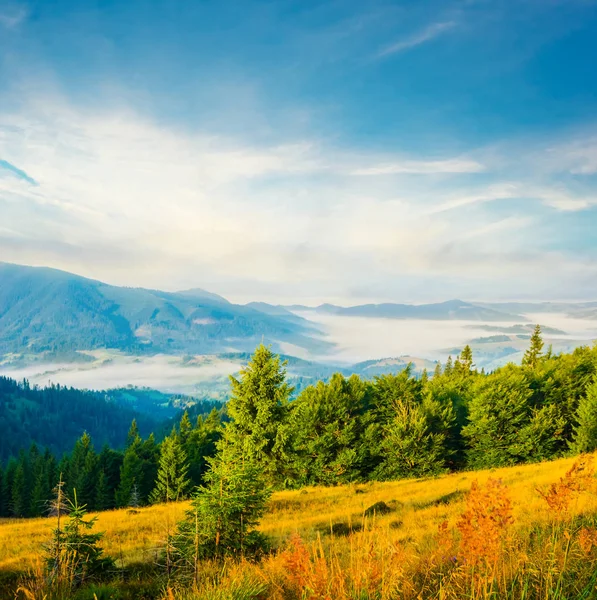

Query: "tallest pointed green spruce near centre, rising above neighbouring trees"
<box><xmin>224</xmin><ymin>344</ymin><xmax>293</xmax><ymax>483</ymax></box>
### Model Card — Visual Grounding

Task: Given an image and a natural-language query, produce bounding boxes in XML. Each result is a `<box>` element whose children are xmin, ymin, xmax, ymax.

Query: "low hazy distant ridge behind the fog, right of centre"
<box><xmin>284</xmin><ymin>300</ymin><xmax>527</xmax><ymax>322</ymax></box>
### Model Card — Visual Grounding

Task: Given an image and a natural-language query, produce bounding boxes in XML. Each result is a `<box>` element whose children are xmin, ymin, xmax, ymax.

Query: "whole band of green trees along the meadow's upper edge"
<box><xmin>0</xmin><ymin>327</ymin><xmax>597</xmax><ymax>516</ymax></box>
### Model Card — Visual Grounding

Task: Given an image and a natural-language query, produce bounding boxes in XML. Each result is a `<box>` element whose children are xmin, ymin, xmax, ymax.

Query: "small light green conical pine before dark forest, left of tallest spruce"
<box><xmin>149</xmin><ymin>431</ymin><xmax>190</xmax><ymax>503</ymax></box>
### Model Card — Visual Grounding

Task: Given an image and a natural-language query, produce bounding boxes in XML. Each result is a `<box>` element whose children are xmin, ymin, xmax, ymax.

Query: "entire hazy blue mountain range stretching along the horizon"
<box><xmin>0</xmin><ymin>263</ymin><xmax>597</xmax><ymax>360</ymax></box>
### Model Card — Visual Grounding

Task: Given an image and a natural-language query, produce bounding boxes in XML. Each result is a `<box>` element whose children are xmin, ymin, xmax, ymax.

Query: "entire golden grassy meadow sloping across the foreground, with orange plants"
<box><xmin>0</xmin><ymin>455</ymin><xmax>597</xmax><ymax>600</ymax></box>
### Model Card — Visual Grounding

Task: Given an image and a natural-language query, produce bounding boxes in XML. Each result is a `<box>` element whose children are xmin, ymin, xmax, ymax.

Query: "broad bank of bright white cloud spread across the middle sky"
<box><xmin>0</xmin><ymin>99</ymin><xmax>593</xmax><ymax>302</ymax></box>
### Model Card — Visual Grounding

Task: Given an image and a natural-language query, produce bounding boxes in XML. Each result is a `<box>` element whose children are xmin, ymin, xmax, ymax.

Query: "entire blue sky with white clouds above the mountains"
<box><xmin>0</xmin><ymin>0</ymin><xmax>597</xmax><ymax>304</ymax></box>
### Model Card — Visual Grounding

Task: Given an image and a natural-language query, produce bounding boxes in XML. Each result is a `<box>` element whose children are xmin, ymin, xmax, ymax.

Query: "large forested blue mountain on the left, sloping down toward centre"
<box><xmin>0</xmin><ymin>263</ymin><xmax>330</xmax><ymax>355</ymax></box>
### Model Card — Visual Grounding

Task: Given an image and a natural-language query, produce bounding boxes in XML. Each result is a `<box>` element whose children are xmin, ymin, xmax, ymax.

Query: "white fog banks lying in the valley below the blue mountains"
<box><xmin>0</xmin><ymin>312</ymin><xmax>597</xmax><ymax>395</ymax></box>
